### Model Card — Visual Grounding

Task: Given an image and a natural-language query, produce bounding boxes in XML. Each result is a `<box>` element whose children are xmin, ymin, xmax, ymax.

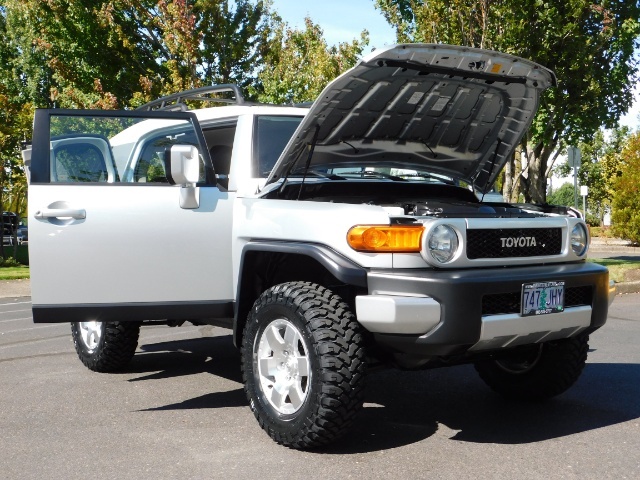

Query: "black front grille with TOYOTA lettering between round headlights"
<box><xmin>467</xmin><ymin>228</ymin><xmax>562</xmax><ymax>259</ymax></box>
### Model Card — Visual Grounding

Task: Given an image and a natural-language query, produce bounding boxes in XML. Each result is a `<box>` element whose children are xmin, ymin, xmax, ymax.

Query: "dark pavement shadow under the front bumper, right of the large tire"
<box><xmin>318</xmin><ymin>363</ymin><xmax>640</xmax><ymax>454</ymax></box>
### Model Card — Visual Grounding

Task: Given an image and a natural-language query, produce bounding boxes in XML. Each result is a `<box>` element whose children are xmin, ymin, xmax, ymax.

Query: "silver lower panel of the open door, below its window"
<box><xmin>29</xmin><ymin>184</ymin><xmax>234</xmax><ymax>305</ymax></box>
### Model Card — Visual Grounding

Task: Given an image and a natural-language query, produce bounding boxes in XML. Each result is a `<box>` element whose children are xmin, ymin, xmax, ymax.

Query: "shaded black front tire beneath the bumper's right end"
<box><xmin>475</xmin><ymin>335</ymin><xmax>589</xmax><ymax>400</ymax></box>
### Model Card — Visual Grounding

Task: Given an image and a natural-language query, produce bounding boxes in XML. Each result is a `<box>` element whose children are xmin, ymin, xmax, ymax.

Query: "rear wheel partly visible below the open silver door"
<box><xmin>71</xmin><ymin>322</ymin><xmax>140</xmax><ymax>373</ymax></box>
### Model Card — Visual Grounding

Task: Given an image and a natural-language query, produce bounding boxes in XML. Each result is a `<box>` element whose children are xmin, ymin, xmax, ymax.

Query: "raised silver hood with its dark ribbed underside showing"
<box><xmin>267</xmin><ymin>44</ymin><xmax>555</xmax><ymax>191</ymax></box>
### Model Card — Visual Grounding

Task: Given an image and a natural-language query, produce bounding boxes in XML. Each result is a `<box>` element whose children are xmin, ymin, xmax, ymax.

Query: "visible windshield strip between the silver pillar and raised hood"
<box><xmin>253</xmin><ymin>115</ymin><xmax>302</xmax><ymax>178</ymax></box>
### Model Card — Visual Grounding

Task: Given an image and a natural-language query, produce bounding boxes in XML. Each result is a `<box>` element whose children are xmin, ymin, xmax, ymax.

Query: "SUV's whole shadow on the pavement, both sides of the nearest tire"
<box><xmin>121</xmin><ymin>335</ymin><xmax>640</xmax><ymax>455</ymax></box>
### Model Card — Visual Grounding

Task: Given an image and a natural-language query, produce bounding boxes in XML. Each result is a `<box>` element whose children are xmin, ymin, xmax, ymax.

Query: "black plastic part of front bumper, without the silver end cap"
<box><xmin>367</xmin><ymin>262</ymin><xmax>609</xmax><ymax>355</ymax></box>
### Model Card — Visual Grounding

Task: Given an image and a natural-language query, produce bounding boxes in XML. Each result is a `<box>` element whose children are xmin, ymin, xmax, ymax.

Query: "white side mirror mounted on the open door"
<box><xmin>165</xmin><ymin>145</ymin><xmax>200</xmax><ymax>208</ymax></box>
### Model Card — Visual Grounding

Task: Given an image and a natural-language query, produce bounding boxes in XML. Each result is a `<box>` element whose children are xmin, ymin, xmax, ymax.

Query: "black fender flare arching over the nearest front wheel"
<box><xmin>233</xmin><ymin>241</ymin><xmax>367</xmax><ymax>348</ymax></box>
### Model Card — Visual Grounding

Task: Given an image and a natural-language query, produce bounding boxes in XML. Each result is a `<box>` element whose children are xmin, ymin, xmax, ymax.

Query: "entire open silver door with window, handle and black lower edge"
<box><xmin>29</xmin><ymin>110</ymin><xmax>234</xmax><ymax>322</ymax></box>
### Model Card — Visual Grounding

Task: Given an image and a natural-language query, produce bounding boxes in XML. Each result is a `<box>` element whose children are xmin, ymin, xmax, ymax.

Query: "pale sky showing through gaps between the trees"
<box><xmin>273</xmin><ymin>0</ymin><xmax>640</xmax><ymax>130</ymax></box>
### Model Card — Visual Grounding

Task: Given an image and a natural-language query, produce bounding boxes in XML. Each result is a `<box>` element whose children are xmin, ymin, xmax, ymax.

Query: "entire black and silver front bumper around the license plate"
<box><xmin>356</xmin><ymin>262</ymin><xmax>615</xmax><ymax>355</ymax></box>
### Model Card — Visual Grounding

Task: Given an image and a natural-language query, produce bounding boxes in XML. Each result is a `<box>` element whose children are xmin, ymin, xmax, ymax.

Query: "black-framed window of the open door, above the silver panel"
<box><xmin>41</xmin><ymin>111</ymin><xmax>213</xmax><ymax>185</ymax></box>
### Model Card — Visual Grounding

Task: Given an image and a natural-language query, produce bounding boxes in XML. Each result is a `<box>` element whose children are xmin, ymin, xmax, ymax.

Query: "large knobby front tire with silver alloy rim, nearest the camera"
<box><xmin>242</xmin><ymin>282</ymin><xmax>365</xmax><ymax>448</ymax></box>
